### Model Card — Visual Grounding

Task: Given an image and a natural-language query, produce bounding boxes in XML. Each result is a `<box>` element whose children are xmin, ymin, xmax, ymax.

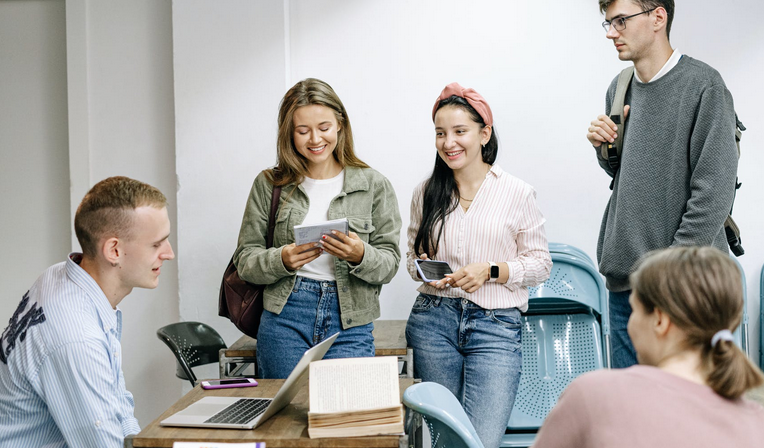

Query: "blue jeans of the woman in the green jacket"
<box><xmin>257</xmin><ymin>277</ymin><xmax>374</xmax><ymax>378</ymax></box>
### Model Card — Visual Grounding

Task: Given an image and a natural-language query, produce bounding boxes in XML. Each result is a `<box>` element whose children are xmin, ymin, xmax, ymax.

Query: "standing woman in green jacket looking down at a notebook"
<box><xmin>234</xmin><ymin>78</ymin><xmax>401</xmax><ymax>378</ymax></box>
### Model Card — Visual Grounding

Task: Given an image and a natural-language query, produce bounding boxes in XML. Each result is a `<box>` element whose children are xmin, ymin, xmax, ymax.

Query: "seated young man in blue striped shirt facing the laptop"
<box><xmin>0</xmin><ymin>177</ymin><xmax>175</xmax><ymax>448</ymax></box>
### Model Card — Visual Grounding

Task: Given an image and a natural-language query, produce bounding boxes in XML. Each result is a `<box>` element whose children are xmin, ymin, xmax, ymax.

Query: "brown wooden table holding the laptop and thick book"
<box><xmin>125</xmin><ymin>378</ymin><xmax>422</xmax><ymax>448</ymax></box>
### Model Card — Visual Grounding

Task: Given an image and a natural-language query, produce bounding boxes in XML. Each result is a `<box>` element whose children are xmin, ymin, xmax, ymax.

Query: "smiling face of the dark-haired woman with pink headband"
<box><xmin>435</xmin><ymin>106</ymin><xmax>491</xmax><ymax>171</ymax></box>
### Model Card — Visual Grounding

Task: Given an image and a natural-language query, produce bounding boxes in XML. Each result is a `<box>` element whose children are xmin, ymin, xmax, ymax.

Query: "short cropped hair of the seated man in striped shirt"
<box><xmin>74</xmin><ymin>176</ymin><xmax>167</xmax><ymax>258</ymax></box>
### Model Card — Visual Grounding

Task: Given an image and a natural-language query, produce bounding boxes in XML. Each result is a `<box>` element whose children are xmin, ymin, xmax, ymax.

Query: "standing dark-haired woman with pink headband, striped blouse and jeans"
<box><xmin>406</xmin><ymin>83</ymin><xmax>552</xmax><ymax>448</ymax></box>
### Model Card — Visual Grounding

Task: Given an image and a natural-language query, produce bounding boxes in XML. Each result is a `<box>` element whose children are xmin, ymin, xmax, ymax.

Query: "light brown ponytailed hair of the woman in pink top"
<box><xmin>629</xmin><ymin>247</ymin><xmax>764</xmax><ymax>399</ymax></box>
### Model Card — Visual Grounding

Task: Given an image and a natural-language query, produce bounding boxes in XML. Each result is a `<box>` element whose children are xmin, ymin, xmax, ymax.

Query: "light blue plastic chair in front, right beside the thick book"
<box><xmin>403</xmin><ymin>382</ymin><xmax>483</xmax><ymax>448</ymax></box>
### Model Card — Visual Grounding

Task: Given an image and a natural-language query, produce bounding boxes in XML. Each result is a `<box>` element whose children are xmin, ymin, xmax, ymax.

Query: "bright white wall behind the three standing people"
<box><xmin>174</xmin><ymin>0</ymin><xmax>764</xmax><ymax>364</ymax></box>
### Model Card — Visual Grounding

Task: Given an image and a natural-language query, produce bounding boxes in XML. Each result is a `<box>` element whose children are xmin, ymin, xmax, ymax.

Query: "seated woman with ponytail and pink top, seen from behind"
<box><xmin>534</xmin><ymin>247</ymin><xmax>764</xmax><ymax>448</ymax></box>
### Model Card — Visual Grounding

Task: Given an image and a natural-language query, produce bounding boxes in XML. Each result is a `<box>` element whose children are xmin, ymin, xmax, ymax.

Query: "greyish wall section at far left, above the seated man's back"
<box><xmin>0</xmin><ymin>0</ymin><xmax>71</xmax><ymax>331</ymax></box>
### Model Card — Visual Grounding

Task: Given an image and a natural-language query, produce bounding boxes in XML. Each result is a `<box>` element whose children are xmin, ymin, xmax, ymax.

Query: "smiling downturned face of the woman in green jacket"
<box><xmin>292</xmin><ymin>104</ymin><xmax>342</xmax><ymax>179</ymax></box>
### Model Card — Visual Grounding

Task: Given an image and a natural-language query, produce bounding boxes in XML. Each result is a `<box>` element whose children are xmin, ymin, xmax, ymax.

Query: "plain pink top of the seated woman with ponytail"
<box><xmin>533</xmin><ymin>366</ymin><xmax>764</xmax><ymax>448</ymax></box>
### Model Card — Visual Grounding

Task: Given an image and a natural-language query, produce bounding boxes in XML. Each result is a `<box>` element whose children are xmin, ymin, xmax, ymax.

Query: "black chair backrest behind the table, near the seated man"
<box><xmin>157</xmin><ymin>322</ymin><xmax>226</xmax><ymax>386</ymax></box>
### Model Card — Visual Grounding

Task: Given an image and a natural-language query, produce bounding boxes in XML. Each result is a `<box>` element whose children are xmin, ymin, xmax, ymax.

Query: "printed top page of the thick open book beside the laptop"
<box><xmin>309</xmin><ymin>356</ymin><xmax>401</xmax><ymax>413</ymax></box>
